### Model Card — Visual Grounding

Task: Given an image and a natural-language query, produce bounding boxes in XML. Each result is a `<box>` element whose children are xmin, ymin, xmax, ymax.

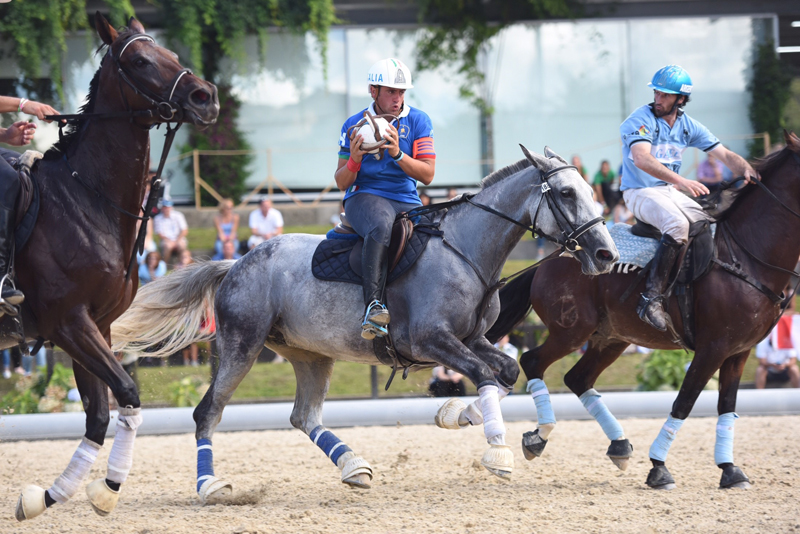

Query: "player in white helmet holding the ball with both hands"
<box><xmin>334</xmin><ymin>58</ymin><xmax>436</xmax><ymax>339</ymax></box>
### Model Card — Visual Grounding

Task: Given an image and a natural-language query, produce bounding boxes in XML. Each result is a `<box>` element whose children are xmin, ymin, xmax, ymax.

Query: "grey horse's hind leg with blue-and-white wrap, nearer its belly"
<box><xmin>289</xmin><ymin>356</ymin><xmax>372</xmax><ymax>489</ymax></box>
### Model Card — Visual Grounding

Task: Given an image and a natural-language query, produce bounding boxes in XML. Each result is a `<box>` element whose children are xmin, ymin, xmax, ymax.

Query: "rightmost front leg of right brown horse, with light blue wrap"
<box><xmin>714</xmin><ymin>350</ymin><xmax>750</xmax><ymax>489</ymax></box>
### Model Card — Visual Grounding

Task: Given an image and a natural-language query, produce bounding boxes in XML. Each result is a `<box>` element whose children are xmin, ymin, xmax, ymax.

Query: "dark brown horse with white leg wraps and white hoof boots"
<box><xmin>11</xmin><ymin>13</ymin><xmax>219</xmax><ymax>521</ymax></box>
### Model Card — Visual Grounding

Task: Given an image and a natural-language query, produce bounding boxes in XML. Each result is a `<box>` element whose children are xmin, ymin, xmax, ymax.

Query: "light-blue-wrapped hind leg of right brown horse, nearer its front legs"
<box><xmin>564</xmin><ymin>342</ymin><xmax>633</xmax><ymax>471</ymax></box>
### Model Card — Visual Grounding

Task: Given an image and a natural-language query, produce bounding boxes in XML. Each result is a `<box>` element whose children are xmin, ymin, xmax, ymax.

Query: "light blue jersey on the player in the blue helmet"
<box><xmin>619</xmin><ymin>104</ymin><xmax>719</xmax><ymax>191</ymax></box>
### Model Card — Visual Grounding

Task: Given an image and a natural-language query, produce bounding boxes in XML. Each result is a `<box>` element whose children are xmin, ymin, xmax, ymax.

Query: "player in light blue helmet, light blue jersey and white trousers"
<box><xmin>620</xmin><ymin>65</ymin><xmax>759</xmax><ymax>332</ymax></box>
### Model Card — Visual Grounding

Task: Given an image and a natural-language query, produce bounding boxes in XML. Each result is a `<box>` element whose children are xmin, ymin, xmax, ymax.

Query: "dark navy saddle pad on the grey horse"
<box><xmin>311</xmin><ymin>216</ymin><xmax>440</xmax><ymax>286</ymax></box>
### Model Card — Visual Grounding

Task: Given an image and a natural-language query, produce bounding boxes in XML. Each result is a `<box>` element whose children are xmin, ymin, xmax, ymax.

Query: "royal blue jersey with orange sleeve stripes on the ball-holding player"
<box><xmin>339</xmin><ymin>104</ymin><xmax>436</xmax><ymax>204</ymax></box>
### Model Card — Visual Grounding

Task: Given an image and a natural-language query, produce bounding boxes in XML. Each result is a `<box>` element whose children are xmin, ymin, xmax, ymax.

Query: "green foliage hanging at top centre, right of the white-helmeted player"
<box><xmin>416</xmin><ymin>0</ymin><xmax>580</xmax><ymax>114</ymax></box>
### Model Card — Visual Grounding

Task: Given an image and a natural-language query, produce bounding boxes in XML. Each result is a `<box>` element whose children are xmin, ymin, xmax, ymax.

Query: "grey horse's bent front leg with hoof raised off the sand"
<box><xmin>434</xmin><ymin>336</ymin><xmax>519</xmax><ymax>430</ymax></box>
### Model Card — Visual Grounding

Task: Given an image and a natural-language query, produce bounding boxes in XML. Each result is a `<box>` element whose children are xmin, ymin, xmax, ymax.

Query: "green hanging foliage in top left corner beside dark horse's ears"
<box><xmin>0</xmin><ymin>0</ymin><xmax>133</xmax><ymax>102</ymax></box>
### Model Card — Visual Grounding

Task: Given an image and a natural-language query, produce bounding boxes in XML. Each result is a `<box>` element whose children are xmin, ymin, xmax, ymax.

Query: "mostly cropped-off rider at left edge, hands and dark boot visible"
<box><xmin>0</xmin><ymin>96</ymin><xmax>58</xmax><ymax>312</ymax></box>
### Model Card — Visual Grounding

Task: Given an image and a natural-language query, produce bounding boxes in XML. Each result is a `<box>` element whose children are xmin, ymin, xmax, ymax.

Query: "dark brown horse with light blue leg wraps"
<box><xmin>486</xmin><ymin>133</ymin><xmax>800</xmax><ymax>488</ymax></box>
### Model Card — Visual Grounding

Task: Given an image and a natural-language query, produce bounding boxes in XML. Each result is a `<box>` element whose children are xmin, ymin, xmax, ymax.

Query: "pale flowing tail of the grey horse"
<box><xmin>111</xmin><ymin>260</ymin><xmax>236</xmax><ymax>357</ymax></box>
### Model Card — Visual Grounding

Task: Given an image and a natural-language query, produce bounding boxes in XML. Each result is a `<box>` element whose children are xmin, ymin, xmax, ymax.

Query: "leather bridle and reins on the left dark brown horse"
<box><xmin>45</xmin><ymin>34</ymin><xmax>192</xmax><ymax>282</ymax></box>
